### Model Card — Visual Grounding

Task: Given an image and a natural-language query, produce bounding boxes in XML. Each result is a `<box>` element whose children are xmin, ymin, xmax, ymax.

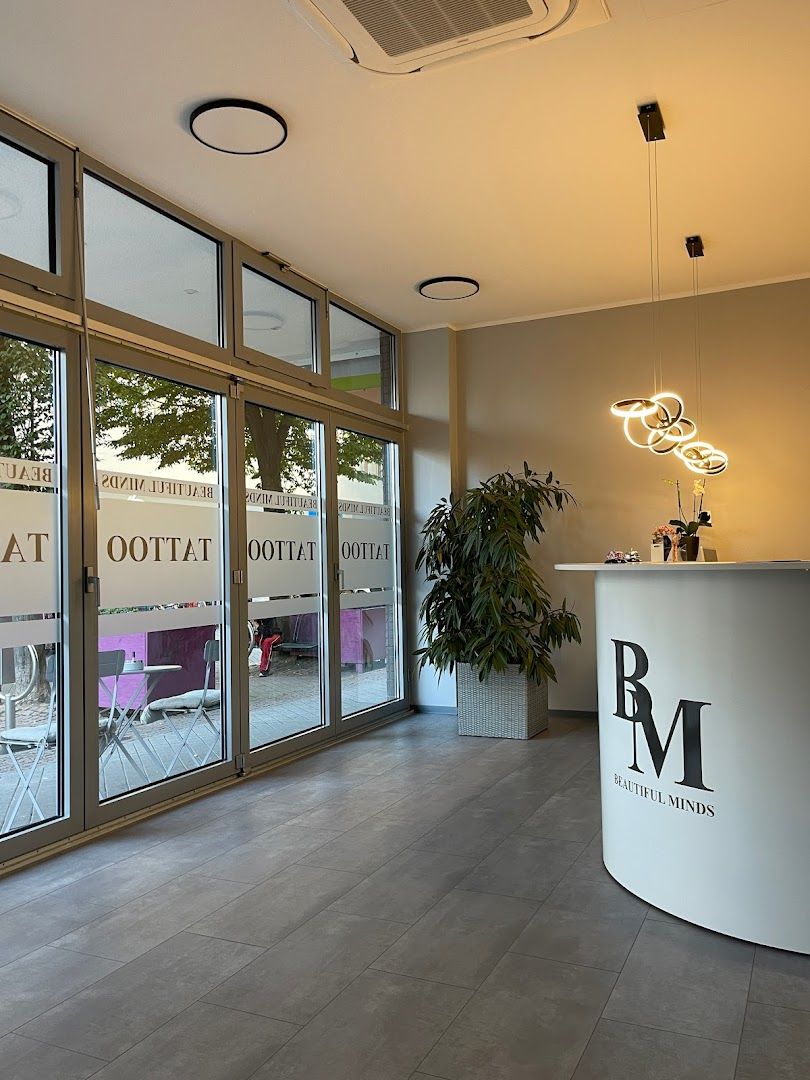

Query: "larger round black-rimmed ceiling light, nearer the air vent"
<box><xmin>189</xmin><ymin>97</ymin><xmax>287</xmax><ymax>154</ymax></box>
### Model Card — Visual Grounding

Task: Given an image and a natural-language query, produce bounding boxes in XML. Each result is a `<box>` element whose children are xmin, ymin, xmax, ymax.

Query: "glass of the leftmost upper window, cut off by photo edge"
<box><xmin>0</xmin><ymin>139</ymin><xmax>56</xmax><ymax>272</ymax></box>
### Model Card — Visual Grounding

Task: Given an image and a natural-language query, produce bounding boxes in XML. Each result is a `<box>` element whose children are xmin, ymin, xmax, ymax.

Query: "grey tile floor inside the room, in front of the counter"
<box><xmin>0</xmin><ymin>716</ymin><xmax>810</xmax><ymax>1080</ymax></box>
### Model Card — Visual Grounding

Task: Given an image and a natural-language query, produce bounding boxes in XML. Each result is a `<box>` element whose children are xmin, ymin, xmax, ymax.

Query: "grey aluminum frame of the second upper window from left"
<box><xmin>77</xmin><ymin>154</ymin><xmax>233</xmax><ymax>362</ymax></box>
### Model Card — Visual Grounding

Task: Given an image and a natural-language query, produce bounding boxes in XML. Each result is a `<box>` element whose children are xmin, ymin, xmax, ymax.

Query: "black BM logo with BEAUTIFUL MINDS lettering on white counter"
<box><xmin>612</xmin><ymin>638</ymin><xmax>714</xmax><ymax>818</ymax></box>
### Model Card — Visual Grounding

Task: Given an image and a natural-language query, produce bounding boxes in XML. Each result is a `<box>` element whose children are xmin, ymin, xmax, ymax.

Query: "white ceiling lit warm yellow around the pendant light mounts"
<box><xmin>0</xmin><ymin>0</ymin><xmax>810</xmax><ymax>329</ymax></box>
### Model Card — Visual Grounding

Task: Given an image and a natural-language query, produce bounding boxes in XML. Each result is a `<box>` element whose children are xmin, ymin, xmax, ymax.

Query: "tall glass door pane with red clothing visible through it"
<box><xmin>245</xmin><ymin>402</ymin><xmax>324</xmax><ymax>750</ymax></box>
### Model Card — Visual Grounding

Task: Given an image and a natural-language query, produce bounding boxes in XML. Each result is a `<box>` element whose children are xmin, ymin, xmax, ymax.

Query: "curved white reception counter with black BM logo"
<box><xmin>556</xmin><ymin>562</ymin><xmax>810</xmax><ymax>954</ymax></box>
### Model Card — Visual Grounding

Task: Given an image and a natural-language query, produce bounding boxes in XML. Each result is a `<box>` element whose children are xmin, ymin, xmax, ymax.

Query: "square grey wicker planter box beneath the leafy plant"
<box><xmin>456</xmin><ymin>664</ymin><xmax>549</xmax><ymax>739</ymax></box>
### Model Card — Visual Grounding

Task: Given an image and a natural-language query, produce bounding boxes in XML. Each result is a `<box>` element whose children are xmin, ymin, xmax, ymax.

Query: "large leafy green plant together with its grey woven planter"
<box><xmin>417</xmin><ymin>462</ymin><xmax>580</xmax><ymax>739</ymax></box>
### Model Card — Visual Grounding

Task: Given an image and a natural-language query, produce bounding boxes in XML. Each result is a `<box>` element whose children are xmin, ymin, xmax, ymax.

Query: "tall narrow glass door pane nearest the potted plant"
<box><xmin>337</xmin><ymin>429</ymin><xmax>402</xmax><ymax>716</ymax></box>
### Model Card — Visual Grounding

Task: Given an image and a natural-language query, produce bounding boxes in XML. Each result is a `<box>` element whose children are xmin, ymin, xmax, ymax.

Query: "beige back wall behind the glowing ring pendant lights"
<box><xmin>458</xmin><ymin>281</ymin><xmax>810</xmax><ymax>710</ymax></box>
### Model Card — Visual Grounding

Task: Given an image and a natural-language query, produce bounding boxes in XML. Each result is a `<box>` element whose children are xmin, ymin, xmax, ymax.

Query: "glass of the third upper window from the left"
<box><xmin>242</xmin><ymin>266</ymin><xmax>315</xmax><ymax>372</ymax></box>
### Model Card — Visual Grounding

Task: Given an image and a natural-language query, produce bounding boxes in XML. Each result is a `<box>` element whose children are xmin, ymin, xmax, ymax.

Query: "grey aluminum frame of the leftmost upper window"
<box><xmin>0</xmin><ymin>111</ymin><xmax>79</xmax><ymax>307</ymax></box>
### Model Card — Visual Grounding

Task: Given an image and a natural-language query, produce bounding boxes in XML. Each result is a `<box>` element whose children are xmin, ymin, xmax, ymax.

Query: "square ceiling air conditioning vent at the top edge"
<box><xmin>287</xmin><ymin>0</ymin><xmax>609</xmax><ymax>75</ymax></box>
